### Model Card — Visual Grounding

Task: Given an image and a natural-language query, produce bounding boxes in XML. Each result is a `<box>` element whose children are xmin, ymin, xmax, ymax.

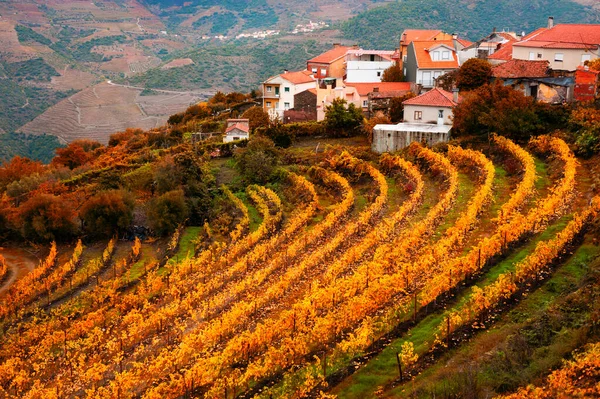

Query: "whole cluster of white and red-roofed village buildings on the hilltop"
<box><xmin>262</xmin><ymin>17</ymin><xmax>600</xmax><ymax>152</ymax></box>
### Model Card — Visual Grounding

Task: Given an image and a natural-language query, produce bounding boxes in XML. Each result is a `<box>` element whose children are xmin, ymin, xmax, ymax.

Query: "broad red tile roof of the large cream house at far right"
<box><xmin>514</xmin><ymin>24</ymin><xmax>600</xmax><ymax>48</ymax></box>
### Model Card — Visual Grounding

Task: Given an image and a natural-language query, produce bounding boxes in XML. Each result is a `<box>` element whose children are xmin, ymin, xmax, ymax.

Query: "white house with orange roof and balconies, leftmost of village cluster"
<box><xmin>262</xmin><ymin>70</ymin><xmax>317</xmax><ymax>119</ymax></box>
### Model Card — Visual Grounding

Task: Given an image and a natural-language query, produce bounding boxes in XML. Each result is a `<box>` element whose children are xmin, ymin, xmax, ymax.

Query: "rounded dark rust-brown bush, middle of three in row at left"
<box><xmin>79</xmin><ymin>190</ymin><xmax>135</xmax><ymax>237</ymax></box>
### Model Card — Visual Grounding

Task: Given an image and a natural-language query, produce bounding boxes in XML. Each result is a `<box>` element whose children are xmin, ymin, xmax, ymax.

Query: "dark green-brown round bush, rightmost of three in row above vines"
<box><xmin>146</xmin><ymin>190</ymin><xmax>188</xmax><ymax>236</ymax></box>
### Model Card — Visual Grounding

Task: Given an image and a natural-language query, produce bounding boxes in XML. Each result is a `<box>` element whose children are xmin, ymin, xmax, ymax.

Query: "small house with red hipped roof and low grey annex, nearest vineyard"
<box><xmin>371</xmin><ymin>88</ymin><xmax>460</xmax><ymax>153</ymax></box>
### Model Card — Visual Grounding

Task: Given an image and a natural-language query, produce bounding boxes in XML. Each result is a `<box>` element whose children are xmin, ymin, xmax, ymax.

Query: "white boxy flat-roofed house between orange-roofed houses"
<box><xmin>346</xmin><ymin>49</ymin><xmax>394</xmax><ymax>83</ymax></box>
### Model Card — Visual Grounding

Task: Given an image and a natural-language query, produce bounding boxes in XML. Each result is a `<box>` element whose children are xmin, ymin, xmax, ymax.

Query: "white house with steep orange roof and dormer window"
<box><xmin>404</xmin><ymin>40</ymin><xmax>460</xmax><ymax>90</ymax></box>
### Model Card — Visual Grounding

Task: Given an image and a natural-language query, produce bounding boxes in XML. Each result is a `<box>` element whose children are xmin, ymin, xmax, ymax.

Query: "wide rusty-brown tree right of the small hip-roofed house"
<box><xmin>453</xmin><ymin>82</ymin><xmax>550</xmax><ymax>140</ymax></box>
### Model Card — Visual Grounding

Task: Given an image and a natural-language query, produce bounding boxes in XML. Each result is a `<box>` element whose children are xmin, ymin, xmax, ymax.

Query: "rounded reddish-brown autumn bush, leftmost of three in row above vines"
<box><xmin>18</xmin><ymin>194</ymin><xmax>75</xmax><ymax>242</ymax></box>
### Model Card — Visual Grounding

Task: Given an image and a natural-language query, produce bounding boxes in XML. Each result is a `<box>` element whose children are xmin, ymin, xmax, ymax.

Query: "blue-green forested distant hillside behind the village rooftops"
<box><xmin>341</xmin><ymin>0</ymin><xmax>600</xmax><ymax>49</ymax></box>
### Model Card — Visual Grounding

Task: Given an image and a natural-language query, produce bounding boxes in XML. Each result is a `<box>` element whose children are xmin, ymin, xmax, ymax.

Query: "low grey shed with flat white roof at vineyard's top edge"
<box><xmin>371</xmin><ymin>123</ymin><xmax>452</xmax><ymax>153</ymax></box>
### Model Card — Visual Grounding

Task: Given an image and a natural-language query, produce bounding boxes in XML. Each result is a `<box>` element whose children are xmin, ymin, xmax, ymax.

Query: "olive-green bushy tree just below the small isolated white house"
<box><xmin>234</xmin><ymin>136</ymin><xmax>279</xmax><ymax>184</ymax></box>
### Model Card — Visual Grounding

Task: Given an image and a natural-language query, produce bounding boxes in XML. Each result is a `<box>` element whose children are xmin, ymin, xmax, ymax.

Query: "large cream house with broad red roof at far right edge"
<box><xmin>512</xmin><ymin>17</ymin><xmax>600</xmax><ymax>72</ymax></box>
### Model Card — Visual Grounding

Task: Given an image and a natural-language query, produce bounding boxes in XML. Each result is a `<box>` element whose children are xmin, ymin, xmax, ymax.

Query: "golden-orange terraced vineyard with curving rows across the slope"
<box><xmin>0</xmin><ymin>136</ymin><xmax>600</xmax><ymax>399</ymax></box>
